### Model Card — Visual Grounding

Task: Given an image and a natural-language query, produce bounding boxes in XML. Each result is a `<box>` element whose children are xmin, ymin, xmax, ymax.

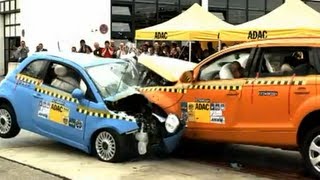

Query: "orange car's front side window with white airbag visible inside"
<box><xmin>198</xmin><ymin>49</ymin><xmax>251</xmax><ymax>81</ymax></box>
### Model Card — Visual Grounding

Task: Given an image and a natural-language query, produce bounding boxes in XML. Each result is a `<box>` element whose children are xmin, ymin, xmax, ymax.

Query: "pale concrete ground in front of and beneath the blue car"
<box><xmin>0</xmin><ymin>131</ymin><xmax>267</xmax><ymax>180</ymax></box>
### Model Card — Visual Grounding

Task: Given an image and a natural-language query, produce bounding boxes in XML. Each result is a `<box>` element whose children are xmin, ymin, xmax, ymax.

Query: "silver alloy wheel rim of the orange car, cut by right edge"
<box><xmin>309</xmin><ymin>135</ymin><xmax>320</xmax><ymax>172</ymax></box>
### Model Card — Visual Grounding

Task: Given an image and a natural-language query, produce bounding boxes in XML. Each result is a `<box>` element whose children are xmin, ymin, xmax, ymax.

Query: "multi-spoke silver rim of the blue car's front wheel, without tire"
<box><xmin>95</xmin><ymin>131</ymin><xmax>116</xmax><ymax>161</ymax></box>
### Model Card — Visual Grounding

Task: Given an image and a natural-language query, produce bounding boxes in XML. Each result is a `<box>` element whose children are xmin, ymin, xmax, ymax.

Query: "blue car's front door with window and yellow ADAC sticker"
<box><xmin>32</xmin><ymin>62</ymin><xmax>89</xmax><ymax>144</ymax></box>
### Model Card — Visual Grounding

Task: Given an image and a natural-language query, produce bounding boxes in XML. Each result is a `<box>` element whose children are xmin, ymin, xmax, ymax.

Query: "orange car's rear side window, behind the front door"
<box><xmin>255</xmin><ymin>47</ymin><xmax>316</xmax><ymax>77</ymax></box>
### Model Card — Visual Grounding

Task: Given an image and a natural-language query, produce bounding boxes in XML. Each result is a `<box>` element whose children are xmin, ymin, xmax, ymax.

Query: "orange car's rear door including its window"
<box><xmin>240</xmin><ymin>47</ymin><xmax>315</xmax><ymax>136</ymax></box>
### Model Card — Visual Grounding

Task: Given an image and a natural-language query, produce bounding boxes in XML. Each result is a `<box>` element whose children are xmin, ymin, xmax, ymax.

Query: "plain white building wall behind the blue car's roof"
<box><xmin>20</xmin><ymin>0</ymin><xmax>111</xmax><ymax>52</ymax></box>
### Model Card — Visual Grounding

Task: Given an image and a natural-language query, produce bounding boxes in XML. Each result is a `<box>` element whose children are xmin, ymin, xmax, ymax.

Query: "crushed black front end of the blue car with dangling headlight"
<box><xmin>105</xmin><ymin>93</ymin><xmax>186</xmax><ymax>155</ymax></box>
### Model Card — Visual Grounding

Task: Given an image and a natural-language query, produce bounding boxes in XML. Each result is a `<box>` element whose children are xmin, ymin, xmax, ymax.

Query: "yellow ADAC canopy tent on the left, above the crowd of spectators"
<box><xmin>135</xmin><ymin>3</ymin><xmax>233</xmax><ymax>41</ymax></box>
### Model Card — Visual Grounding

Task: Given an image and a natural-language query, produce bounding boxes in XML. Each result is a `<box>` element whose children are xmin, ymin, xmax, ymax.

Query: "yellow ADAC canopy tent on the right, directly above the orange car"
<box><xmin>220</xmin><ymin>0</ymin><xmax>320</xmax><ymax>41</ymax></box>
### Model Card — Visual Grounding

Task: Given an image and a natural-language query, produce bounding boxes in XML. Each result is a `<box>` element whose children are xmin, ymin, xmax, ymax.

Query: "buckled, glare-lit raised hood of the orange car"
<box><xmin>138</xmin><ymin>55</ymin><xmax>197</xmax><ymax>82</ymax></box>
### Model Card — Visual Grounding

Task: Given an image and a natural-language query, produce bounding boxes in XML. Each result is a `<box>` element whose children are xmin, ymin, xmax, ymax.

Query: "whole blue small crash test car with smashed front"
<box><xmin>0</xmin><ymin>52</ymin><xmax>185</xmax><ymax>162</ymax></box>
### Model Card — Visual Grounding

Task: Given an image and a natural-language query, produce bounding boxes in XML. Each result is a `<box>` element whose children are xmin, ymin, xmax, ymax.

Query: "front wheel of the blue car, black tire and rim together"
<box><xmin>92</xmin><ymin>130</ymin><xmax>128</xmax><ymax>162</ymax></box>
